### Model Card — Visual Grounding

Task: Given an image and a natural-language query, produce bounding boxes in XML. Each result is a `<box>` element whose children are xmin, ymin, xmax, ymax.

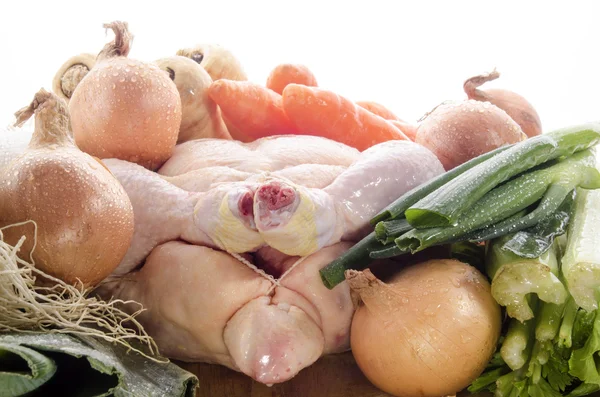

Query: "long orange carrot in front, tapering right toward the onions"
<box><xmin>283</xmin><ymin>84</ymin><xmax>409</xmax><ymax>151</ymax></box>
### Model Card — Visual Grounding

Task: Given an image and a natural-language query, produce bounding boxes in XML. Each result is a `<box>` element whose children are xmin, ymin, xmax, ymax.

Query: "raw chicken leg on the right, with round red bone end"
<box><xmin>254</xmin><ymin>141</ymin><xmax>444</xmax><ymax>256</ymax></box>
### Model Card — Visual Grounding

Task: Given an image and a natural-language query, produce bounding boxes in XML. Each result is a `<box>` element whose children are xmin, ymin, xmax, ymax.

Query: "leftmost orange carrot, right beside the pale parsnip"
<box><xmin>208</xmin><ymin>79</ymin><xmax>295</xmax><ymax>142</ymax></box>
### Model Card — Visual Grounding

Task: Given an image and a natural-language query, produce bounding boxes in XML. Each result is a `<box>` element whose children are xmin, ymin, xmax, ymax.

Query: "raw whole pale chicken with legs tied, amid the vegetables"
<box><xmin>98</xmin><ymin>136</ymin><xmax>444</xmax><ymax>384</ymax></box>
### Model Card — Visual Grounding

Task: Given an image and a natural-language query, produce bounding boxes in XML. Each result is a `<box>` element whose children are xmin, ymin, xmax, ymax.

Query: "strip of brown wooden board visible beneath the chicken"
<box><xmin>177</xmin><ymin>352</ymin><xmax>488</xmax><ymax>397</ymax></box>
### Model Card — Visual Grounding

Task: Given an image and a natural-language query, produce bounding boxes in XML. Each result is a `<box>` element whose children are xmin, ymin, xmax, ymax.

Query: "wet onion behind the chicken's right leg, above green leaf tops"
<box><xmin>415</xmin><ymin>99</ymin><xmax>527</xmax><ymax>171</ymax></box>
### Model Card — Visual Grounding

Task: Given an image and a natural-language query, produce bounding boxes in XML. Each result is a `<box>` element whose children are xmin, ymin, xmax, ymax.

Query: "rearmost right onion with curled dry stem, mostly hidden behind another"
<box><xmin>463</xmin><ymin>69</ymin><xmax>542</xmax><ymax>137</ymax></box>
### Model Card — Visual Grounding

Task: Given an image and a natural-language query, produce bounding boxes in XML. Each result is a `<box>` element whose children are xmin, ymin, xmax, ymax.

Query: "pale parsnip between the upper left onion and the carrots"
<box><xmin>155</xmin><ymin>55</ymin><xmax>232</xmax><ymax>143</ymax></box>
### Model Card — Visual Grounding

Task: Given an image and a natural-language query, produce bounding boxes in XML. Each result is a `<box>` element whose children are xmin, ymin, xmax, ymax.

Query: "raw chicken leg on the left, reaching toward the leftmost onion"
<box><xmin>103</xmin><ymin>159</ymin><xmax>264</xmax><ymax>275</ymax></box>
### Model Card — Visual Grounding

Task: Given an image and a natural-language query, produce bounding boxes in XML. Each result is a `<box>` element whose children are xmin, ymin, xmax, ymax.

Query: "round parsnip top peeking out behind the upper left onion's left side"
<box><xmin>52</xmin><ymin>53</ymin><xmax>96</xmax><ymax>102</ymax></box>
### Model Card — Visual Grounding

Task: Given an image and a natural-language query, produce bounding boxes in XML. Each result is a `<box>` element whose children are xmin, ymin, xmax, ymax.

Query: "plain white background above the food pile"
<box><xmin>0</xmin><ymin>0</ymin><xmax>600</xmax><ymax>130</ymax></box>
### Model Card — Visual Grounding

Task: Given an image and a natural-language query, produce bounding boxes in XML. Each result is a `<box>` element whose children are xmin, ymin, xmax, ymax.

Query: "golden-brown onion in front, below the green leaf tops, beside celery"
<box><xmin>346</xmin><ymin>259</ymin><xmax>501</xmax><ymax>397</ymax></box>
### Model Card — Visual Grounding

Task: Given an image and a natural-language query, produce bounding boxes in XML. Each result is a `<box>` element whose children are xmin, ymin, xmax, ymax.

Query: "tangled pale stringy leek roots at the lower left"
<box><xmin>0</xmin><ymin>221</ymin><xmax>168</xmax><ymax>363</ymax></box>
